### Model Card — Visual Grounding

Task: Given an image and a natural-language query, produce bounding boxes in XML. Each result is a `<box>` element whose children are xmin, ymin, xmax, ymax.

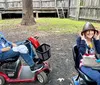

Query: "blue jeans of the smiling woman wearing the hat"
<box><xmin>81</xmin><ymin>66</ymin><xmax>100</xmax><ymax>85</ymax></box>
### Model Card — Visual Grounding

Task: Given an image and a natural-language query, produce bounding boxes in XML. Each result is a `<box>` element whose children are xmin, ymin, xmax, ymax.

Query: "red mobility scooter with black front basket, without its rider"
<box><xmin>0</xmin><ymin>37</ymin><xmax>51</xmax><ymax>85</ymax></box>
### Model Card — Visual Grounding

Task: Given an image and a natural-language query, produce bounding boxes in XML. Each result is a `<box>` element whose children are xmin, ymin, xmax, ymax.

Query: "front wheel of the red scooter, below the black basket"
<box><xmin>37</xmin><ymin>72</ymin><xmax>48</xmax><ymax>84</ymax></box>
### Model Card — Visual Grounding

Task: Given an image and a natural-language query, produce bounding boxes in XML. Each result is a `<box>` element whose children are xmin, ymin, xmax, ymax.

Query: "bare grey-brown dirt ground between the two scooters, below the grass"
<box><xmin>1</xmin><ymin>28</ymin><xmax>77</xmax><ymax>85</ymax></box>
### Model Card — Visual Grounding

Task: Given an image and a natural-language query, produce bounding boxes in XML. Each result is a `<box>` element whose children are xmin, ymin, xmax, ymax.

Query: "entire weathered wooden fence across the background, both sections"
<box><xmin>0</xmin><ymin>0</ymin><xmax>100</xmax><ymax>21</ymax></box>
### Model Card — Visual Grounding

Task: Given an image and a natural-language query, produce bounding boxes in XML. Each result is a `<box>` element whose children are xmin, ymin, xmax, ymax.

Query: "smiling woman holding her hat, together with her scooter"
<box><xmin>72</xmin><ymin>22</ymin><xmax>100</xmax><ymax>85</ymax></box>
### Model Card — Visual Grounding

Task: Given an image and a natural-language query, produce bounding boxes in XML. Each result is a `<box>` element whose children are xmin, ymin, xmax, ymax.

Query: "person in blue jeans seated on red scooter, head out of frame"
<box><xmin>0</xmin><ymin>33</ymin><xmax>43</xmax><ymax>72</ymax></box>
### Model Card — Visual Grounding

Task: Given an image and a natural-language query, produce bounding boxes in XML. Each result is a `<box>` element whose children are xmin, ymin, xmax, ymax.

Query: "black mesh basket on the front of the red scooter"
<box><xmin>36</xmin><ymin>44</ymin><xmax>51</xmax><ymax>61</ymax></box>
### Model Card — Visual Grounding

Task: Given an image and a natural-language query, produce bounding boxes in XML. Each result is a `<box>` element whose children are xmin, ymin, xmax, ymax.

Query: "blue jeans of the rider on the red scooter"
<box><xmin>0</xmin><ymin>49</ymin><xmax>35</xmax><ymax>66</ymax></box>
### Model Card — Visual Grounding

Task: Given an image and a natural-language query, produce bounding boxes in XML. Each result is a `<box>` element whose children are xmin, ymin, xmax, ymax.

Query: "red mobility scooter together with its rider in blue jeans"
<box><xmin>0</xmin><ymin>33</ymin><xmax>51</xmax><ymax>85</ymax></box>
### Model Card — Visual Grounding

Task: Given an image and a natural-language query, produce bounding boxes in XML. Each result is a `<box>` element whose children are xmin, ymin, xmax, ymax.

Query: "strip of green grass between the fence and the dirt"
<box><xmin>0</xmin><ymin>18</ymin><xmax>100</xmax><ymax>33</ymax></box>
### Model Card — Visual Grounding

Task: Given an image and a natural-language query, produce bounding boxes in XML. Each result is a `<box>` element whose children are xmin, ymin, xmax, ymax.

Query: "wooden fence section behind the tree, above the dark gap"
<box><xmin>0</xmin><ymin>0</ymin><xmax>68</xmax><ymax>9</ymax></box>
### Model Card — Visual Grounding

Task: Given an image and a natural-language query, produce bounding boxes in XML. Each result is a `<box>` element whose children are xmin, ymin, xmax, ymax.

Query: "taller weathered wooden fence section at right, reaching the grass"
<box><xmin>69</xmin><ymin>0</ymin><xmax>100</xmax><ymax>21</ymax></box>
